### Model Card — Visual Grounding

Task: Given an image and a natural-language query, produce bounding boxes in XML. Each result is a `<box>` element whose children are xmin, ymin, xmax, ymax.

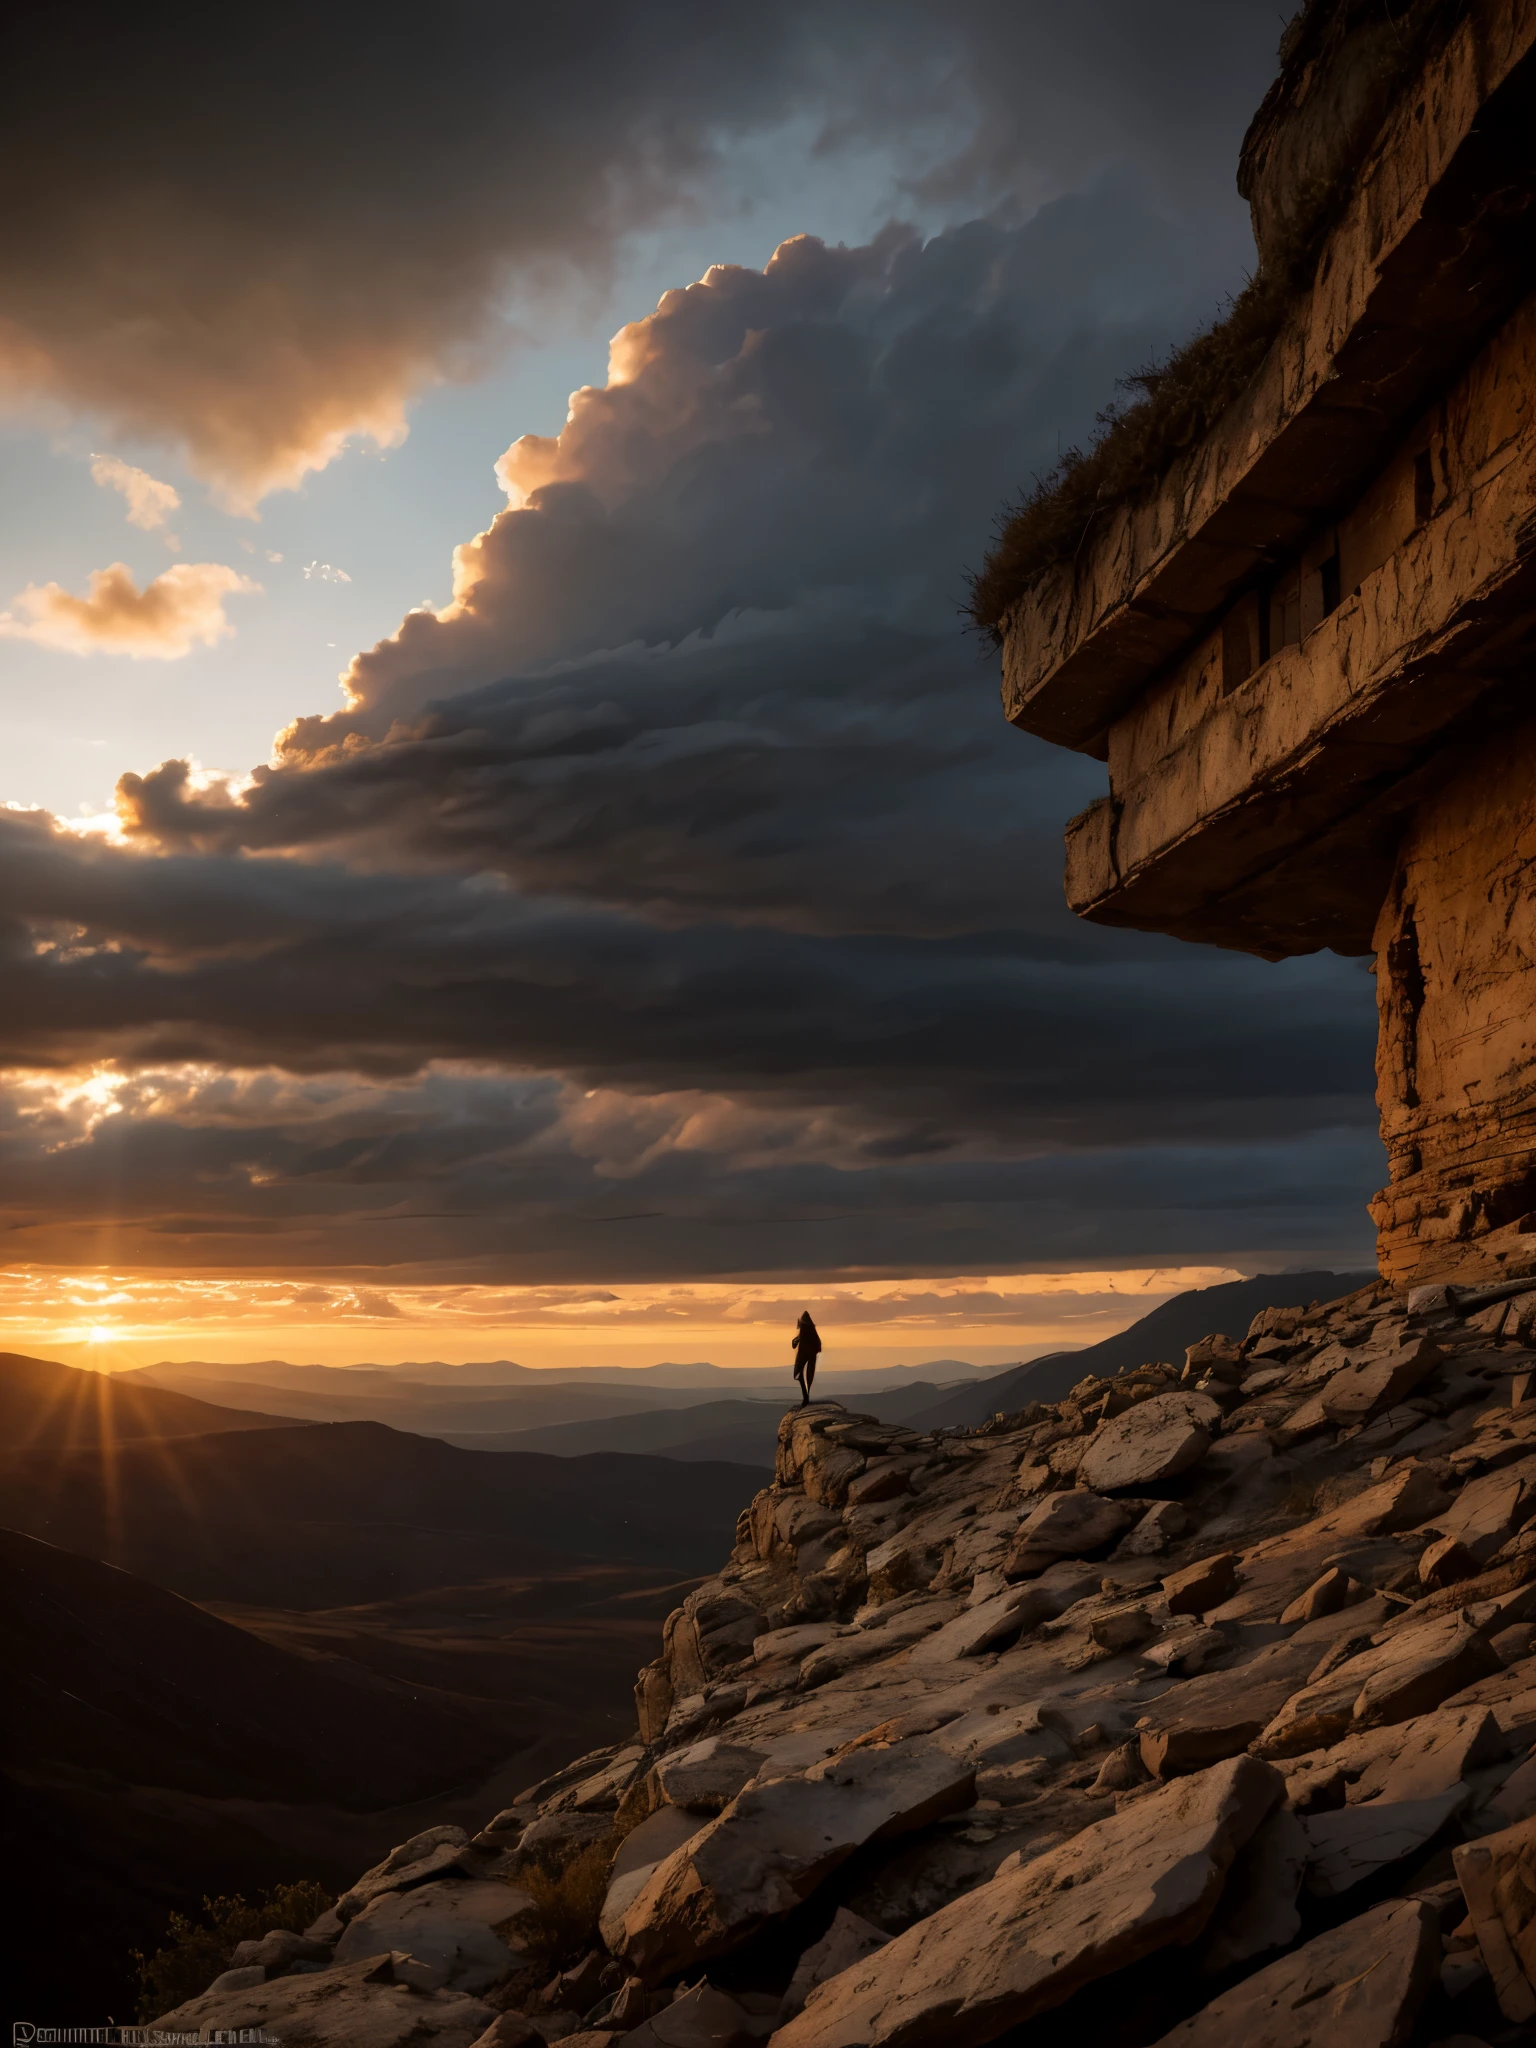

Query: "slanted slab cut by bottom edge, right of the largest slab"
<box><xmin>1157</xmin><ymin>1898</ymin><xmax>1440</xmax><ymax>2048</ymax></box>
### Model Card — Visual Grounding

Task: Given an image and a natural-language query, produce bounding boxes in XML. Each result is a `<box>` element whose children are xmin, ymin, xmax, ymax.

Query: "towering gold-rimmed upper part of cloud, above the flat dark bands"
<box><xmin>121</xmin><ymin>209</ymin><xmax>1217</xmax><ymax>954</ymax></box>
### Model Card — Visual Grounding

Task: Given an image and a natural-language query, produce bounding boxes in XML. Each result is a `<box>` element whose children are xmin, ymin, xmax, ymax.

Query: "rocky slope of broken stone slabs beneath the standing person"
<box><xmin>162</xmin><ymin>1282</ymin><xmax>1536</xmax><ymax>2048</ymax></box>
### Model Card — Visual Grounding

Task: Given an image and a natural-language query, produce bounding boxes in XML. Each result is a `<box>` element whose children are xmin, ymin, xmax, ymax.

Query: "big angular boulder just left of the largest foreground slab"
<box><xmin>623</xmin><ymin>1739</ymin><xmax>975</xmax><ymax>1982</ymax></box>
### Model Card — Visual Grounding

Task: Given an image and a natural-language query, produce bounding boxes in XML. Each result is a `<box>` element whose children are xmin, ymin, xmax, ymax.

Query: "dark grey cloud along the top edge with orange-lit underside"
<box><xmin>0</xmin><ymin>0</ymin><xmax>1278</xmax><ymax>506</ymax></box>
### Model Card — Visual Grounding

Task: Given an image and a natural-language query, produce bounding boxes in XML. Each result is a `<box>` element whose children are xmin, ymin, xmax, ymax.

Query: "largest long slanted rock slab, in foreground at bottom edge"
<box><xmin>774</xmin><ymin>1757</ymin><xmax>1282</xmax><ymax>2048</ymax></box>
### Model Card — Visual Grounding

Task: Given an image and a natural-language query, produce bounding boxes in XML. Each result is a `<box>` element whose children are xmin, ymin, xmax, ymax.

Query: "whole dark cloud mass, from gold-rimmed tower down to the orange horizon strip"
<box><xmin>0</xmin><ymin>180</ymin><xmax>1374</xmax><ymax>1280</ymax></box>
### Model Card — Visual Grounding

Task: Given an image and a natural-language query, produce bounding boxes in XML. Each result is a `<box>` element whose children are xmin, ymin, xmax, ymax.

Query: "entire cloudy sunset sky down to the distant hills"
<box><xmin>0</xmin><ymin>0</ymin><xmax>1382</xmax><ymax>1366</ymax></box>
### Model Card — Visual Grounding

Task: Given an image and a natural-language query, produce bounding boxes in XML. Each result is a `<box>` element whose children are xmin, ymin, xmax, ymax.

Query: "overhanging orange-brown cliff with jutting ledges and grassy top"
<box><xmin>1004</xmin><ymin>0</ymin><xmax>1536</xmax><ymax>1284</ymax></box>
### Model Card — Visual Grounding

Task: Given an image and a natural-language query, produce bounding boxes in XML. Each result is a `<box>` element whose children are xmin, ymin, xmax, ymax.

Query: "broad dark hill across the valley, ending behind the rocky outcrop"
<box><xmin>0</xmin><ymin>1421</ymin><xmax>762</xmax><ymax>1608</ymax></box>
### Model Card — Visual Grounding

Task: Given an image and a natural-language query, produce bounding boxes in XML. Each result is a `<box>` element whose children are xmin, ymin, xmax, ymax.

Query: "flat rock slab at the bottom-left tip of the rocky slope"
<box><xmin>156</xmin><ymin>1956</ymin><xmax>496</xmax><ymax>2048</ymax></box>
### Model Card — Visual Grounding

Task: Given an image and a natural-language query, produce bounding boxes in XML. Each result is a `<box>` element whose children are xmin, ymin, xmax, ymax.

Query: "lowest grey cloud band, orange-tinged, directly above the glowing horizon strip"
<box><xmin>0</xmin><ymin>1069</ymin><xmax>1372</xmax><ymax>1286</ymax></box>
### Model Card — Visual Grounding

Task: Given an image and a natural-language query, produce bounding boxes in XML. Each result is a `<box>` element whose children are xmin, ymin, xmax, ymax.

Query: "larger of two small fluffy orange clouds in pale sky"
<box><xmin>0</xmin><ymin>561</ymin><xmax>262</xmax><ymax>662</ymax></box>
